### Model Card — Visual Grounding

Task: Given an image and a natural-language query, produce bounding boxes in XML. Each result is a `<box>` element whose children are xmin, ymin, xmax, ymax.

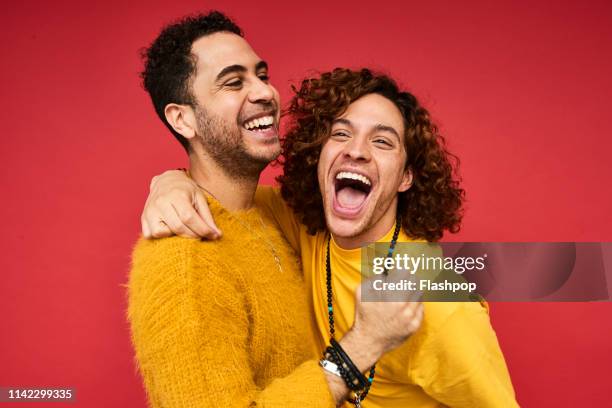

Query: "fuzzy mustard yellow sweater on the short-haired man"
<box><xmin>128</xmin><ymin>199</ymin><xmax>334</xmax><ymax>408</ymax></box>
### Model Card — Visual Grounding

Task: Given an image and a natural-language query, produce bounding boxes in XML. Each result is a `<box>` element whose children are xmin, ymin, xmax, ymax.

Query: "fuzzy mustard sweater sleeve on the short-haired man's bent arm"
<box><xmin>128</xmin><ymin>238</ymin><xmax>334</xmax><ymax>408</ymax></box>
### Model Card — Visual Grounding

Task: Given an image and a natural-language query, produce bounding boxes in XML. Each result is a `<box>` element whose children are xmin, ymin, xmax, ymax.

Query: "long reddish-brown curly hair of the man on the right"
<box><xmin>277</xmin><ymin>68</ymin><xmax>465</xmax><ymax>241</ymax></box>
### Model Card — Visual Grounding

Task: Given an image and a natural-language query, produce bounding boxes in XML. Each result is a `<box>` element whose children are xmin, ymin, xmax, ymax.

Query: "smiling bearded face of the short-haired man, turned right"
<box><xmin>191</xmin><ymin>32</ymin><xmax>280</xmax><ymax>172</ymax></box>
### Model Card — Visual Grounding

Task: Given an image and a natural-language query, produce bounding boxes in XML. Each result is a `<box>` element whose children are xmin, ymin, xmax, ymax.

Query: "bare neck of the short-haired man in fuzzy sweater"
<box><xmin>189</xmin><ymin>153</ymin><xmax>259</xmax><ymax>211</ymax></box>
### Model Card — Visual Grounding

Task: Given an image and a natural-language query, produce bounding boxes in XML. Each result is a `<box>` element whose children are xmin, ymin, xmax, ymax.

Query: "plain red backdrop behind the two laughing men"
<box><xmin>0</xmin><ymin>1</ymin><xmax>612</xmax><ymax>407</ymax></box>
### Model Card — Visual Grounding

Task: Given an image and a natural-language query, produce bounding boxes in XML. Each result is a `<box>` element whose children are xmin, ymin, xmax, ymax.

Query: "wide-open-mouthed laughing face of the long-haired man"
<box><xmin>318</xmin><ymin>94</ymin><xmax>412</xmax><ymax>248</ymax></box>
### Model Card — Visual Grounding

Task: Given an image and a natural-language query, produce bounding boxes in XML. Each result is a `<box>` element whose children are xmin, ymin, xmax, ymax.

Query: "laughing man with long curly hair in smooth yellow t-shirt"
<box><xmin>143</xmin><ymin>69</ymin><xmax>517</xmax><ymax>407</ymax></box>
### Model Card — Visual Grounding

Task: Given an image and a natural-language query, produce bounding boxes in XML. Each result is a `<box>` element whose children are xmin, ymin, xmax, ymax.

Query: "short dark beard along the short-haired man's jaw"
<box><xmin>195</xmin><ymin>106</ymin><xmax>275</xmax><ymax>180</ymax></box>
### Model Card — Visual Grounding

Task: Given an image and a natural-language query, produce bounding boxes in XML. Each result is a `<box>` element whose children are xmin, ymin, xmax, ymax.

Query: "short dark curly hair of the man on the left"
<box><xmin>140</xmin><ymin>11</ymin><xmax>243</xmax><ymax>151</ymax></box>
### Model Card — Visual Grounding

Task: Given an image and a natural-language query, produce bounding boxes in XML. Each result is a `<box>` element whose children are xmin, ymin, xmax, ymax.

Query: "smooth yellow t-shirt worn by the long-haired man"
<box><xmin>256</xmin><ymin>187</ymin><xmax>518</xmax><ymax>408</ymax></box>
